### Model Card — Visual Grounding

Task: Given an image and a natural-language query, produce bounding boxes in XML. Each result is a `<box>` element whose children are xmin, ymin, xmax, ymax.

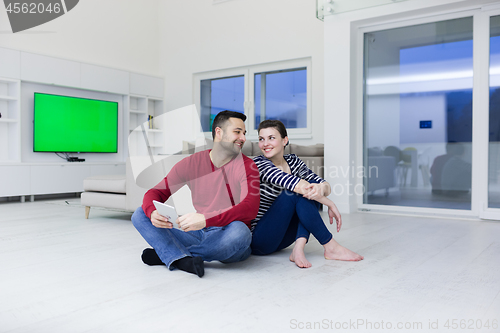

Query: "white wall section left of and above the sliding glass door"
<box><xmin>324</xmin><ymin>0</ymin><xmax>495</xmax><ymax>213</ymax></box>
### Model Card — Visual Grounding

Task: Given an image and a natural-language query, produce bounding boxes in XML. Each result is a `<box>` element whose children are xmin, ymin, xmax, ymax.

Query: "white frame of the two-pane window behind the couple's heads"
<box><xmin>193</xmin><ymin>57</ymin><xmax>312</xmax><ymax>141</ymax></box>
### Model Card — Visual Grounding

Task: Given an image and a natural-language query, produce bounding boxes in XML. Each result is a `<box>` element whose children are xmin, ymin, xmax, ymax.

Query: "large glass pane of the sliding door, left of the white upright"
<box><xmin>363</xmin><ymin>17</ymin><xmax>473</xmax><ymax>210</ymax></box>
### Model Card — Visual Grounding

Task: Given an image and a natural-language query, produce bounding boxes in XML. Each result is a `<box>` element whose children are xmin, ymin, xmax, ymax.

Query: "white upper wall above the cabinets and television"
<box><xmin>0</xmin><ymin>0</ymin><xmax>159</xmax><ymax>75</ymax></box>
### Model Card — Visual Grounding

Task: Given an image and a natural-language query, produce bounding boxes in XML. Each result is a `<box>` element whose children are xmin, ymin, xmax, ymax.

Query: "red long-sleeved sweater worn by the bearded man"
<box><xmin>142</xmin><ymin>150</ymin><xmax>260</xmax><ymax>227</ymax></box>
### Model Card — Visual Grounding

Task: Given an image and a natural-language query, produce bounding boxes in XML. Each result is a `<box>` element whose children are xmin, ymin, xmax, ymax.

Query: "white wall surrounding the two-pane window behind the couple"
<box><xmin>160</xmin><ymin>0</ymin><xmax>324</xmax><ymax>144</ymax></box>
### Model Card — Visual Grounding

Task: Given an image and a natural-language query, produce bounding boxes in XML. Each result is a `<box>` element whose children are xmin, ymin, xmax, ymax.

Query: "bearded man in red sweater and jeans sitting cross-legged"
<box><xmin>132</xmin><ymin>111</ymin><xmax>260</xmax><ymax>277</ymax></box>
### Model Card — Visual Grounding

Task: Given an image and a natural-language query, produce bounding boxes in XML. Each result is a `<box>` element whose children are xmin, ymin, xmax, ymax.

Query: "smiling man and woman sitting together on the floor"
<box><xmin>132</xmin><ymin>111</ymin><xmax>363</xmax><ymax>277</ymax></box>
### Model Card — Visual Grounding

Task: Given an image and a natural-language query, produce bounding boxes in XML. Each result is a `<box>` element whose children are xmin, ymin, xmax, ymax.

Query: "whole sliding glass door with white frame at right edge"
<box><xmin>358</xmin><ymin>8</ymin><xmax>500</xmax><ymax>220</ymax></box>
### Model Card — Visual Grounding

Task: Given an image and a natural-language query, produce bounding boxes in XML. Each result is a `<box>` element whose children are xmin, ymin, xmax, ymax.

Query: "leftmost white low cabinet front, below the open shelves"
<box><xmin>0</xmin><ymin>165</ymin><xmax>30</xmax><ymax>197</ymax></box>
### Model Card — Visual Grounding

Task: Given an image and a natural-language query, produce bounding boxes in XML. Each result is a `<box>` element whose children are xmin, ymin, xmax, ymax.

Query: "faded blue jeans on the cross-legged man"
<box><xmin>132</xmin><ymin>207</ymin><xmax>252</xmax><ymax>270</ymax></box>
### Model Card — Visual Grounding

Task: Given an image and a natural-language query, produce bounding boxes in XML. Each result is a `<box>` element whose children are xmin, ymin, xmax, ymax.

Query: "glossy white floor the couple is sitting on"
<box><xmin>0</xmin><ymin>198</ymin><xmax>500</xmax><ymax>333</ymax></box>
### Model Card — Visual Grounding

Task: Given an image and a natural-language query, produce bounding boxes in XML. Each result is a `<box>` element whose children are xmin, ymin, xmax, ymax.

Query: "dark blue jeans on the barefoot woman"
<box><xmin>251</xmin><ymin>190</ymin><xmax>333</xmax><ymax>255</ymax></box>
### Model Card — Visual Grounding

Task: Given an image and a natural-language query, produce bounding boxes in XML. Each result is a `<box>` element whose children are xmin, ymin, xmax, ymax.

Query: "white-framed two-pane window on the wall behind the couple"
<box><xmin>193</xmin><ymin>59</ymin><xmax>312</xmax><ymax>137</ymax></box>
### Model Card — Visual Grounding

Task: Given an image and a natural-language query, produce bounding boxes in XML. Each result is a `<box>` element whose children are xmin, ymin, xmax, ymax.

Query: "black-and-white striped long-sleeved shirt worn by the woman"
<box><xmin>251</xmin><ymin>154</ymin><xmax>325</xmax><ymax>231</ymax></box>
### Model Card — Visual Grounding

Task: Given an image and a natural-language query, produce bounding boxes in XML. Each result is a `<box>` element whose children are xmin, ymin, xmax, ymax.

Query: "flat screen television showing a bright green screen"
<box><xmin>33</xmin><ymin>93</ymin><xmax>118</xmax><ymax>153</ymax></box>
